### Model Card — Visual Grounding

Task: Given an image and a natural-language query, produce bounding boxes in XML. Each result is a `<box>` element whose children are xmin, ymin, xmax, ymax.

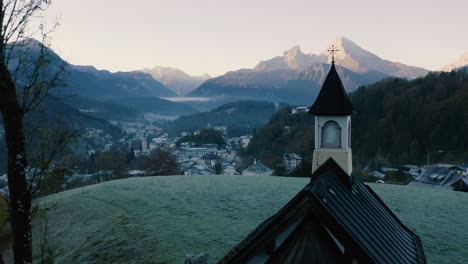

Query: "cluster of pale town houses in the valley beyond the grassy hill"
<box><xmin>113</xmin><ymin>123</ymin><xmax>304</xmax><ymax>176</ymax></box>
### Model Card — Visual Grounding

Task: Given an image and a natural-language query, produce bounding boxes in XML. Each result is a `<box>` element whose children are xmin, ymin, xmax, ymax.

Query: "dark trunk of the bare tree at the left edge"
<box><xmin>0</xmin><ymin>65</ymin><xmax>32</xmax><ymax>264</ymax></box>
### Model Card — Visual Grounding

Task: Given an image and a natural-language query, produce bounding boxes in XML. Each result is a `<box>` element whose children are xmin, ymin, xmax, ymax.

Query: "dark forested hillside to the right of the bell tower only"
<box><xmin>350</xmin><ymin>69</ymin><xmax>468</xmax><ymax>164</ymax></box>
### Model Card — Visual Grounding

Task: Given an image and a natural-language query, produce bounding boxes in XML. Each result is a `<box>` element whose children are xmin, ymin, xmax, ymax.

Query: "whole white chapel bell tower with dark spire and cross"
<box><xmin>309</xmin><ymin>46</ymin><xmax>354</xmax><ymax>175</ymax></box>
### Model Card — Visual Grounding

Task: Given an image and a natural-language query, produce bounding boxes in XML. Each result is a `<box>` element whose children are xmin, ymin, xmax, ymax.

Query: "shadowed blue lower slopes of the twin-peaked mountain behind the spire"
<box><xmin>190</xmin><ymin>64</ymin><xmax>389</xmax><ymax>104</ymax></box>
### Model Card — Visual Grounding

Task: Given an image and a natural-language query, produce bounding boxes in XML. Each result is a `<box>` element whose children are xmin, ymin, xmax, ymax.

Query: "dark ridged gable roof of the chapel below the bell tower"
<box><xmin>219</xmin><ymin>159</ymin><xmax>426</xmax><ymax>263</ymax></box>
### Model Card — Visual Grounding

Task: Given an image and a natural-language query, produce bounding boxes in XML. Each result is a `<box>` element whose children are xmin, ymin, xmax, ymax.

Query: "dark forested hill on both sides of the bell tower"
<box><xmin>245</xmin><ymin>69</ymin><xmax>468</xmax><ymax>168</ymax></box>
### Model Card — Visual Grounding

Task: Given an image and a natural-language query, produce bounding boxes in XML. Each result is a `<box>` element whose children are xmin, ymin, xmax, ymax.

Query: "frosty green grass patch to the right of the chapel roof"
<box><xmin>369</xmin><ymin>184</ymin><xmax>468</xmax><ymax>264</ymax></box>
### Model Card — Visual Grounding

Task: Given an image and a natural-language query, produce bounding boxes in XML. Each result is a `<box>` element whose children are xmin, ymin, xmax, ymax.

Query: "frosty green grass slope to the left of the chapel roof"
<box><xmin>35</xmin><ymin>176</ymin><xmax>308</xmax><ymax>263</ymax></box>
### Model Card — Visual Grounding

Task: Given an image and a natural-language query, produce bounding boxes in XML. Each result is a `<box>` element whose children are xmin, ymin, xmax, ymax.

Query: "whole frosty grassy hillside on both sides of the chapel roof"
<box><xmin>1</xmin><ymin>176</ymin><xmax>468</xmax><ymax>263</ymax></box>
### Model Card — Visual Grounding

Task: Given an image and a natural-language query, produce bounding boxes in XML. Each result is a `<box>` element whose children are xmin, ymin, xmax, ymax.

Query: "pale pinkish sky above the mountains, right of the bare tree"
<box><xmin>39</xmin><ymin>0</ymin><xmax>468</xmax><ymax>76</ymax></box>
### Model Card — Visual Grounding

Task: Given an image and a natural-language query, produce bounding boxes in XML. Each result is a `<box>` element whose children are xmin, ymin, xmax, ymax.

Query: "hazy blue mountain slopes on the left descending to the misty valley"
<box><xmin>10</xmin><ymin>39</ymin><xmax>197</xmax><ymax>120</ymax></box>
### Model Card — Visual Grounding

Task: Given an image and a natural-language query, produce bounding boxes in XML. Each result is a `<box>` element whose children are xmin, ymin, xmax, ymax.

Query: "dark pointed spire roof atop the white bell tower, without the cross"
<box><xmin>309</xmin><ymin>62</ymin><xmax>354</xmax><ymax>116</ymax></box>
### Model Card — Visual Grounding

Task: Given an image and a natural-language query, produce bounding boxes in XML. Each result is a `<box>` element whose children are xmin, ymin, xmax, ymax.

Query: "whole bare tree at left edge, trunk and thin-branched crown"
<box><xmin>0</xmin><ymin>0</ymin><xmax>64</xmax><ymax>263</ymax></box>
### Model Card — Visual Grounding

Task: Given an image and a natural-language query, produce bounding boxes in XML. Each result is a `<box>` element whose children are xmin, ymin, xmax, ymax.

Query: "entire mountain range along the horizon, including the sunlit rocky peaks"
<box><xmin>5</xmin><ymin>37</ymin><xmax>468</xmax><ymax>126</ymax></box>
